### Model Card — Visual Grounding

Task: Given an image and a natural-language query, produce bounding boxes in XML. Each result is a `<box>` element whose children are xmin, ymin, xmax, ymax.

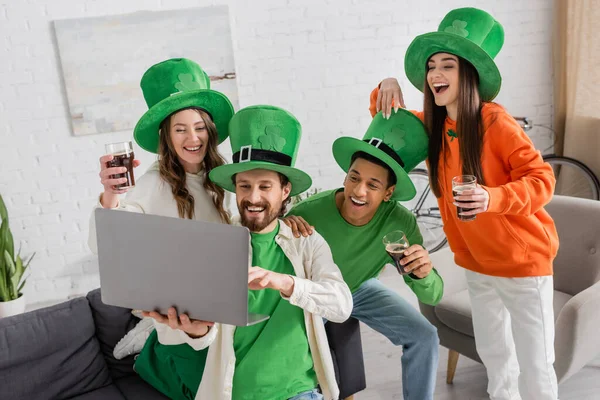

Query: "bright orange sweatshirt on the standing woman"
<box><xmin>369</xmin><ymin>88</ymin><xmax>558</xmax><ymax>278</ymax></box>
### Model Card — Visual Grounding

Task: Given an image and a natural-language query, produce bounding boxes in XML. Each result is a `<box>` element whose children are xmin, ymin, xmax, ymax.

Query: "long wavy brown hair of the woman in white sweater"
<box><xmin>158</xmin><ymin>107</ymin><xmax>230</xmax><ymax>224</ymax></box>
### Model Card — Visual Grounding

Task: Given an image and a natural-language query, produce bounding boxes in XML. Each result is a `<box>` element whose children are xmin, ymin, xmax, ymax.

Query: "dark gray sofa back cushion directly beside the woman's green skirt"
<box><xmin>87</xmin><ymin>289</ymin><xmax>139</xmax><ymax>379</ymax></box>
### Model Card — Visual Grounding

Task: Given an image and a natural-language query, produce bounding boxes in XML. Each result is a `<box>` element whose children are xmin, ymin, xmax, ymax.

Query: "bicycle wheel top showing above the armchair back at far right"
<box><xmin>543</xmin><ymin>154</ymin><xmax>600</xmax><ymax>200</ymax></box>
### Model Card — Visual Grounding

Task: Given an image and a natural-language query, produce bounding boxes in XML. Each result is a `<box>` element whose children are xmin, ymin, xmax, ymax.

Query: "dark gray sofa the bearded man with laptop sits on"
<box><xmin>0</xmin><ymin>289</ymin><xmax>365</xmax><ymax>400</ymax></box>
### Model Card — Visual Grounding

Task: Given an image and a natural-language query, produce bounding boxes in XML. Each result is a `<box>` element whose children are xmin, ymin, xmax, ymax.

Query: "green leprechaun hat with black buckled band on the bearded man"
<box><xmin>209</xmin><ymin>106</ymin><xmax>312</xmax><ymax>196</ymax></box>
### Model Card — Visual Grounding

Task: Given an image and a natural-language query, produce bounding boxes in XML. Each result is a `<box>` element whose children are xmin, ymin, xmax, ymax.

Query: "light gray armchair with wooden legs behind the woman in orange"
<box><xmin>419</xmin><ymin>196</ymin><xmax>600</xmax><ymax>383</ymax></box>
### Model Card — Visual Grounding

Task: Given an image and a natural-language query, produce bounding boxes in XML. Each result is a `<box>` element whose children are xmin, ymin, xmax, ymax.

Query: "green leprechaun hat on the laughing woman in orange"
<box><xmin>404</xmin><ymin>8</ymin><xmax>504</xmax><ymax>101</ymax></box>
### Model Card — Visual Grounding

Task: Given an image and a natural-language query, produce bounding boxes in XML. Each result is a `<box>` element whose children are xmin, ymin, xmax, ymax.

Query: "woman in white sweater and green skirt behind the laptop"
<box><xmin>89</xmin><ymin>59</ymin><xmax>233</xmax><ymax>398</ymax></box>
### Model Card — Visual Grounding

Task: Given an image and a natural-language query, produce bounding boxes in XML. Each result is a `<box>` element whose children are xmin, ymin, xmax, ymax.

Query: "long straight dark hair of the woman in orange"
<box><xmin>423</xmin><ymin>57</ymin><xmax>485</xmax><ymax>197</ymax></box>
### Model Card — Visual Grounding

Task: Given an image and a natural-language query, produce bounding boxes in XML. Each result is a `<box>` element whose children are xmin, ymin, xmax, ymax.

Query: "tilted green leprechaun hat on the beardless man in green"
<box><xmin>333</xmin><ymin>108</ymin><xmax>429</xmax><ymax>201</ymax></box>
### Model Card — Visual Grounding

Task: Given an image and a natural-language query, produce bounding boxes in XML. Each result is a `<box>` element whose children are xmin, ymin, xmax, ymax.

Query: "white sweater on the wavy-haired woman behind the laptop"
<box><xmin>88</xmin><ymin>162</ymin><xmax>230</xmax><ymax>254</ymax></box>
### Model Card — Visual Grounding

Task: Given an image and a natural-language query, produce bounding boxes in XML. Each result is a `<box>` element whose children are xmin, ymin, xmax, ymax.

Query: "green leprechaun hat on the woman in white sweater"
<box><xmin>133</xmin><ymin>58</ymin><xmax>234</xmax><ymax>153</ymax></box>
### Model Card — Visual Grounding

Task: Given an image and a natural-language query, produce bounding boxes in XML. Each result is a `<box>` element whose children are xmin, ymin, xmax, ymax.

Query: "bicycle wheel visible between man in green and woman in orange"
<box><xmin>400</xmin><ymin>169</ymin><xmax>447</xmax><ymax>253</ymax></box>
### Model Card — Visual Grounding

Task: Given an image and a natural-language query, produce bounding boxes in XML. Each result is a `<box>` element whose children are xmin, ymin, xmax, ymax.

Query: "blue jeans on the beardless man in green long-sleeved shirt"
<box><xmin>351</xmin><ymin>278</ymin><xmax>439</xmax><ymax>400</ymax></box>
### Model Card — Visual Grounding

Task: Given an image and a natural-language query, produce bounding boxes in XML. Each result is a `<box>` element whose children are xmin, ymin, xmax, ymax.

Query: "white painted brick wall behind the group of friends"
<box><xmin>0</xmin><ymin>0</ymin><xmax>552</xmax><ymax>303</ymax></box>
